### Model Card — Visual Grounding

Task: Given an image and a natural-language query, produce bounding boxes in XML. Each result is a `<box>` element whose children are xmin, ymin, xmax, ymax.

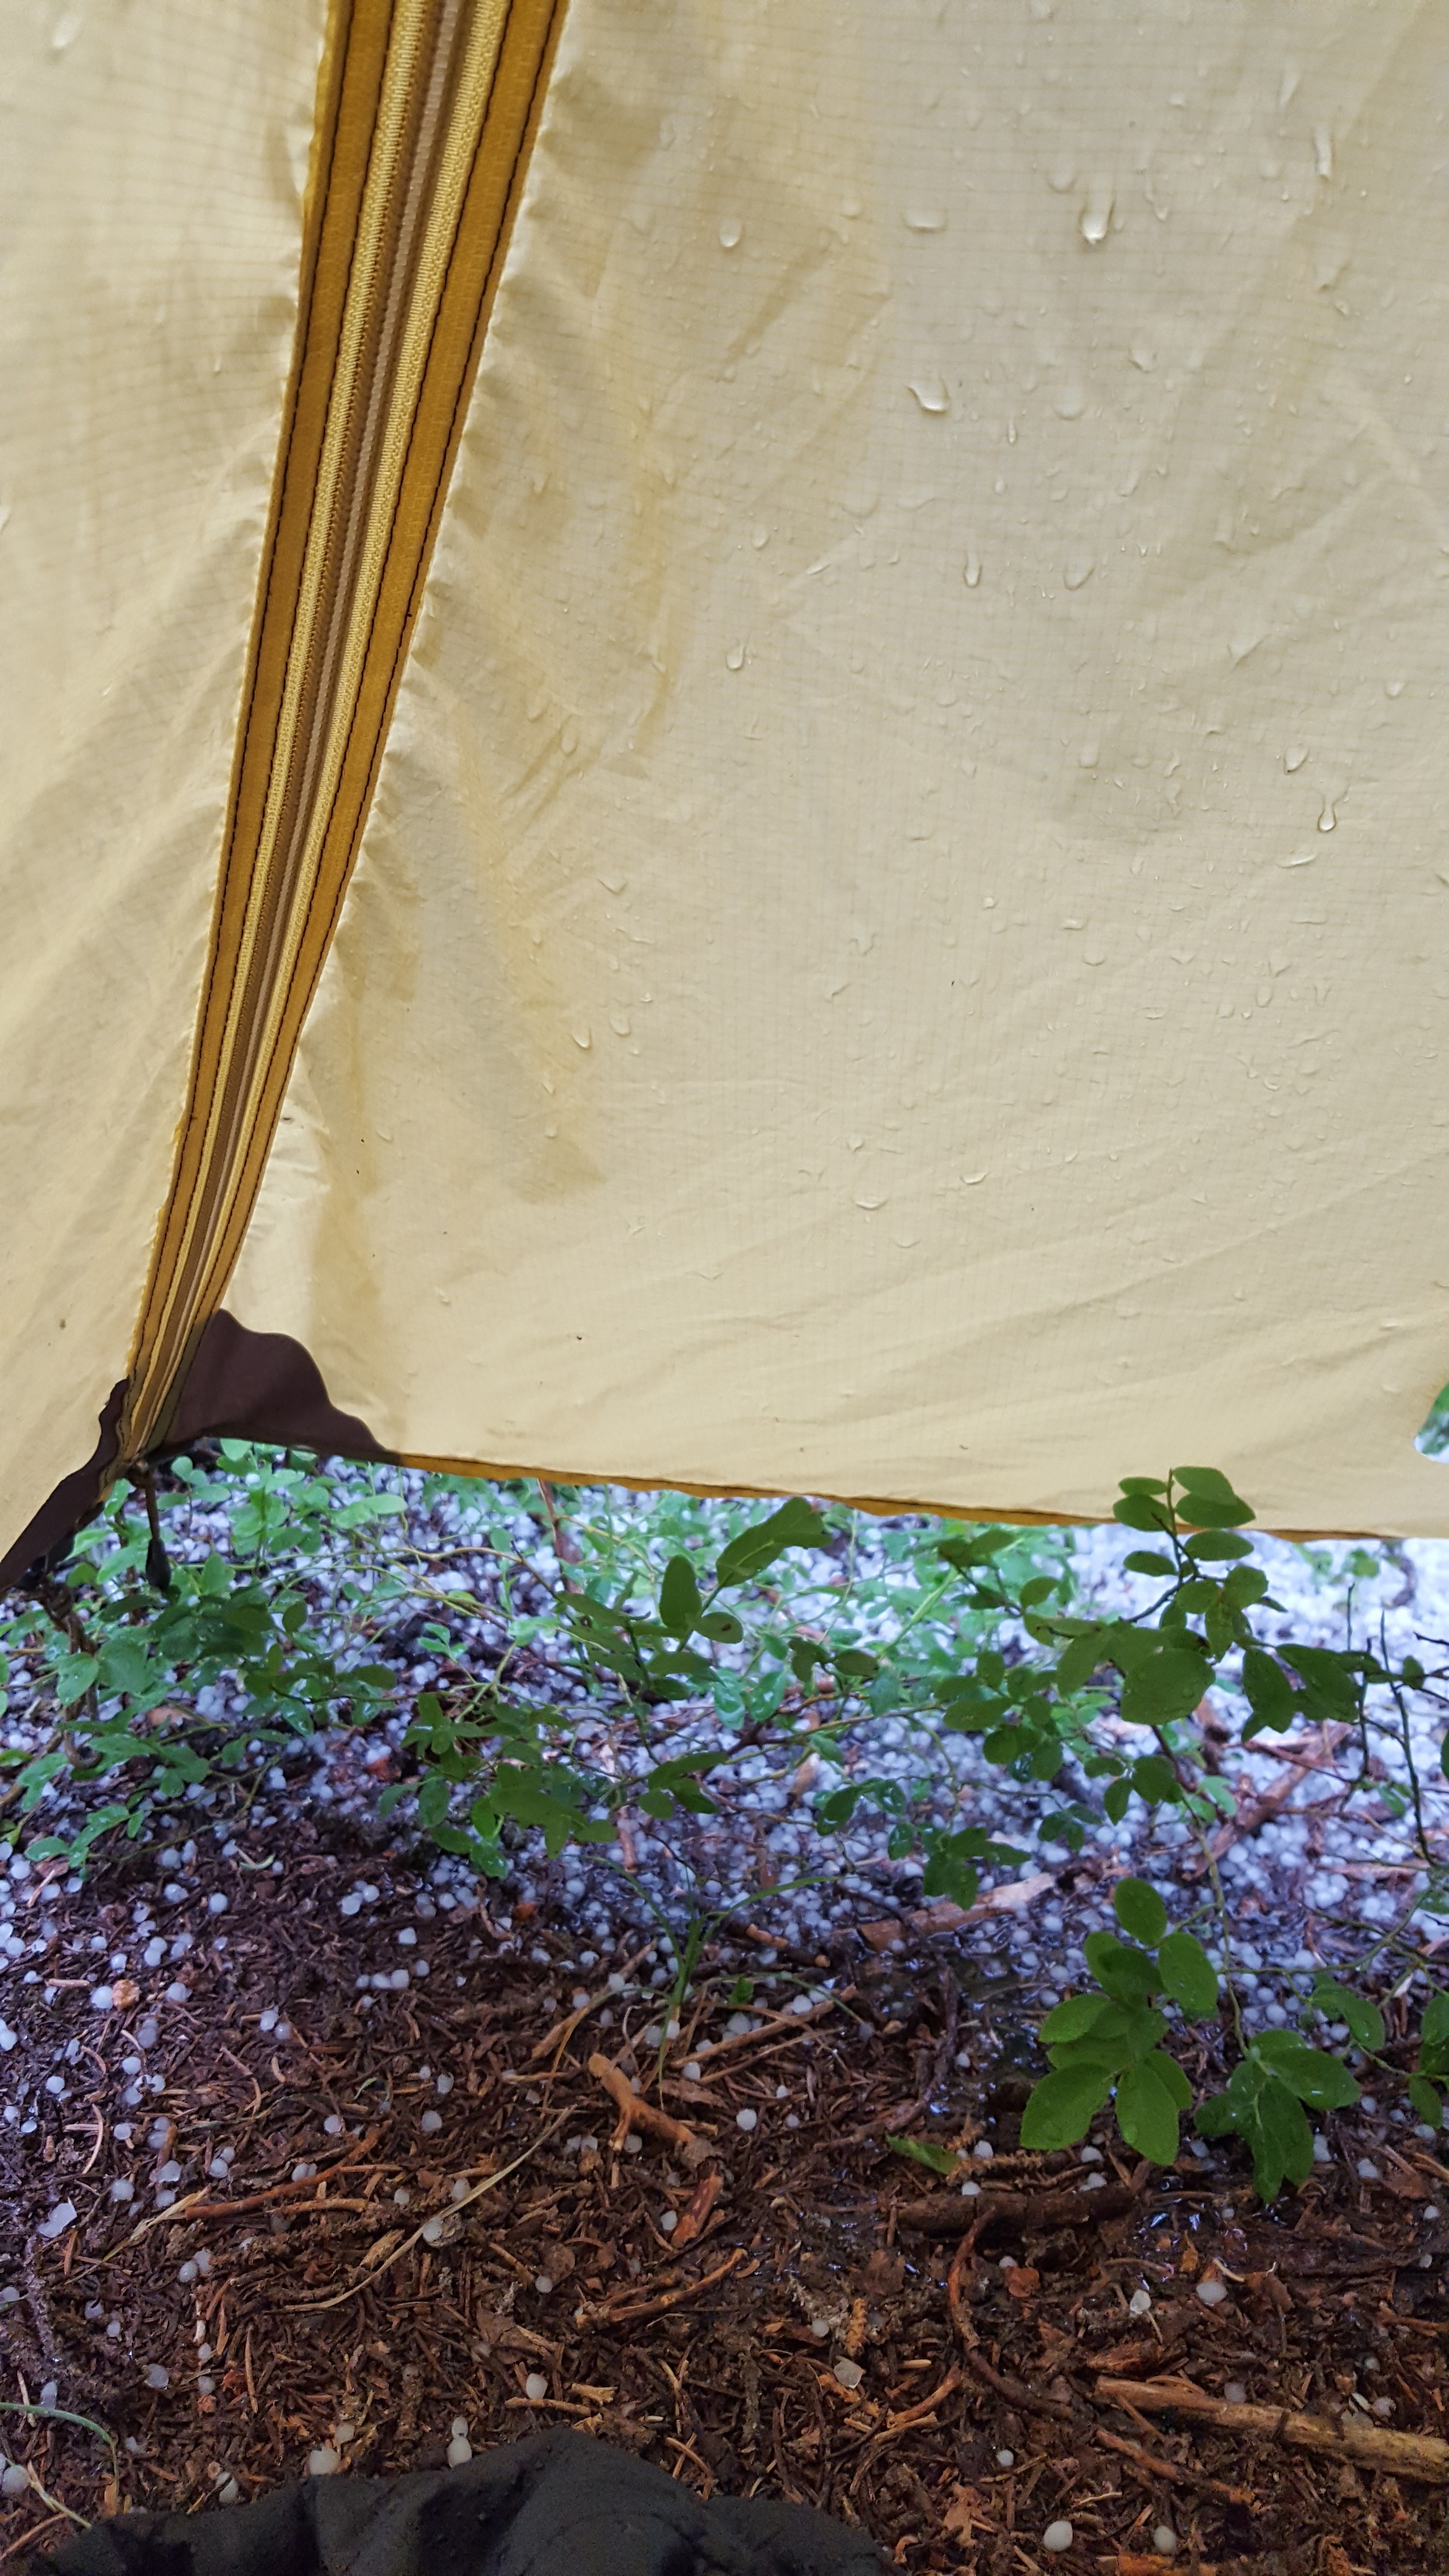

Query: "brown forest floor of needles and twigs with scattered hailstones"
<box><xmin>0</xmin><ymin>1811</ymin><xmax>1449</xmax><ymax>2576</ymax></box>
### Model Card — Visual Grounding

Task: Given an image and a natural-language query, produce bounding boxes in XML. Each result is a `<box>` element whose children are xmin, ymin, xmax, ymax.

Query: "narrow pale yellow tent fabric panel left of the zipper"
<box><xmin>0</xmin><ymin>0</ymin><xmax>325</xmax><ymax>1548</ymax></box>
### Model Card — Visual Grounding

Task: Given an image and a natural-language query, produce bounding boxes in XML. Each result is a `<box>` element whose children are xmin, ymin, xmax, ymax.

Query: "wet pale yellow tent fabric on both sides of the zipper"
<box><xmin>0</xmin><ymin>0</ymin><xmax>1449</xmax><ymax>1533</ymax></box>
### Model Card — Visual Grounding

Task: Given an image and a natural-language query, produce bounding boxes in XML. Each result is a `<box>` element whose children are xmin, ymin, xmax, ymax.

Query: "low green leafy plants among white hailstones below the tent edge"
<box><xmin>0</xmin><ymin>1443</ymin><xmax>1449</xmax><ymax>2195</ymax></box>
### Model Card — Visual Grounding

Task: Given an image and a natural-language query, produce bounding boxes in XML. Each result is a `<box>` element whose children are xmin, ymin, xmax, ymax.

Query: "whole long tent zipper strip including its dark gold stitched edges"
<box><xmin>113</xmin><ymin>0</ymin><xmax>562</xmax><ymax>1473</ymax></box>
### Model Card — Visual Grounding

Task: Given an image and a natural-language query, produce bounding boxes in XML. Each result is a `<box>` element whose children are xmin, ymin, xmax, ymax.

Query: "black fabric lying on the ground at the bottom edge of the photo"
<box><xmin>26</xmin><ymin>2432</ymin><xmax>885</xmax><ymax>2576</ymax></box>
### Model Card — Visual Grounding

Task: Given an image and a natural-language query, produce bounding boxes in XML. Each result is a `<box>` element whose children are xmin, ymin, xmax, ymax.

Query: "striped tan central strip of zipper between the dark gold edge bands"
<box><xmin>124</xmin><ymin>0</ymin><xmax>531</xmax><ymax>1458</ymax></box>
